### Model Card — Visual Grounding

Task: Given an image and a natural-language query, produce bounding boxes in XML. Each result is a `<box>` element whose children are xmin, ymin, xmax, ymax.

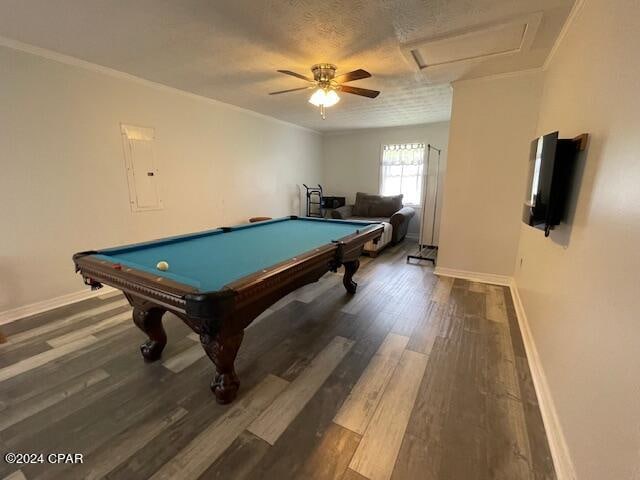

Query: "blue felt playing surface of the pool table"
<box><xmin>95</xmin><ymin>218</ymin><xmax>375</xmax><ymax>292</ymax></box>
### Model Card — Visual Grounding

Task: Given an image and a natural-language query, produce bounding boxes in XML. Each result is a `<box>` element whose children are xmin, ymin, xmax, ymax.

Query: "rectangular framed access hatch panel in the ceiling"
<box><xmin>400</xmin><ymin>12</ymin><xmax>542</xmax><ymax>70</ymax></box>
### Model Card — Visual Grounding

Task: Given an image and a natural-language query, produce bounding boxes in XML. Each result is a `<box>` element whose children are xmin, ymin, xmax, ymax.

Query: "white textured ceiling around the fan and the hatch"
<box><xmin>0</xmin><ymin>0</ymin><xmax>573</xmax><ymax>130</ymax></box>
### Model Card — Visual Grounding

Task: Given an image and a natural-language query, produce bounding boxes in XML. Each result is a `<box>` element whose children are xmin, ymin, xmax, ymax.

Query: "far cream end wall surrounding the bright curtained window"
<box><xmin>323</xmin><ymin>122</ymin><xmax>449</xmax><ymax>237</ymax></box>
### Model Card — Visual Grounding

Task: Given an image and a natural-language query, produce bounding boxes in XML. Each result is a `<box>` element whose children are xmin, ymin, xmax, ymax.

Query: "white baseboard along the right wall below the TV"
<box><xmin>509</xmin><ymin>280</ymin><xmax>576</xmax><ymax>480</ymax></box>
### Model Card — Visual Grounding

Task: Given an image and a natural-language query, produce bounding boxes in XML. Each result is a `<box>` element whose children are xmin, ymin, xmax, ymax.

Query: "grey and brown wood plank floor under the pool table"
<box><xmin>0</xmin><ymin>244</ymin><xmax>555</xmax><ymax>480</ymax></box>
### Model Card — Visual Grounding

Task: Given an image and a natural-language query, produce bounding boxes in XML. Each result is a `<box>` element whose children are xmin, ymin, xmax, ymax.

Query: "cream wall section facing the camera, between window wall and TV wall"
<box><xmin>438</xmin><ymin>72</ymin><xmax>542</xmax><ymax>276</ymax></box>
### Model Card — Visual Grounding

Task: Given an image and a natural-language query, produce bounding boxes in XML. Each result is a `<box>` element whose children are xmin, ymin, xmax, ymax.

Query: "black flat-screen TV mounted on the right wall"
<box><xmin>522</xmin><ymin>132</ymin><xmax>579</xmax><ymax>237</ymax></box>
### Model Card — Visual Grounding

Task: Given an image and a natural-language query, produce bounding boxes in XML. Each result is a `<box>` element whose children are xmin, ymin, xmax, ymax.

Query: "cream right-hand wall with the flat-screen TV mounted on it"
<box><xmin>516</xmin><ymin>0</ymin><xmax>640</xmax><ymax>480</ymax></box>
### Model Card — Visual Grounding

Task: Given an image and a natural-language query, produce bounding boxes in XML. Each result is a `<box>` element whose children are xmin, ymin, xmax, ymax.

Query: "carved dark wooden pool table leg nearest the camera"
<box><xmin>200</xmin><ymin>331</ymin><xmax>244</xmax><ymax>404</ymax></box>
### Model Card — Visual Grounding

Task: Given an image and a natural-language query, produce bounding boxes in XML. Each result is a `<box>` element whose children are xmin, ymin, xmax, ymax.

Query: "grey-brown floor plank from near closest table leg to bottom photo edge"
<box><xmin>151</xmin><ymin>375</ymin><xmax>288</xmax><ymax>480</ymax></box>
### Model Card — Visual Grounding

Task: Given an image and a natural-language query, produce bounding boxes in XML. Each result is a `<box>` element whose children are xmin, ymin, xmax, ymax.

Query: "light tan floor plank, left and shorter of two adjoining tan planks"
<box><xmin>333</xmin><ymin>333</ymin><xmax>409</xmax><ymax>435</ymax></box>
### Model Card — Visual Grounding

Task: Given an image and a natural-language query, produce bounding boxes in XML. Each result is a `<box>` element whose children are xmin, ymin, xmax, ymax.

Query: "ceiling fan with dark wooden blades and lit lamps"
<box><xmin>269</xmin><ymin>63</ymin><xmax>380</xmax><ymax>120</ymax></box>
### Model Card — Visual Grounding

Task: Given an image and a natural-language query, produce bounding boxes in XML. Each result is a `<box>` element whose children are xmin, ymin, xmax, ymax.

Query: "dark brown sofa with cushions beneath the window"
<box><xmin>331</xmin><ymin>192</ymin><xmax>416</xmax><ymax>249</ymax></box>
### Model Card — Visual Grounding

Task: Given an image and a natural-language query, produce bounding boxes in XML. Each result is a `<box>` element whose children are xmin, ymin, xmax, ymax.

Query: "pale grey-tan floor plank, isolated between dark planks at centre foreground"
<box><xmin>247</xmin><ymin>337</ymin><xmax>353</xmax><ymax>445</ymax></box>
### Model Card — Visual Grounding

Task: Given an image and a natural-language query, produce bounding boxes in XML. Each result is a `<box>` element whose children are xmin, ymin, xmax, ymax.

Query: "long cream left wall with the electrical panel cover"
<box><xmin>0</xmin><ymin>47</ymin><xmax>322</xmax><ymax>312</ymax></box>
